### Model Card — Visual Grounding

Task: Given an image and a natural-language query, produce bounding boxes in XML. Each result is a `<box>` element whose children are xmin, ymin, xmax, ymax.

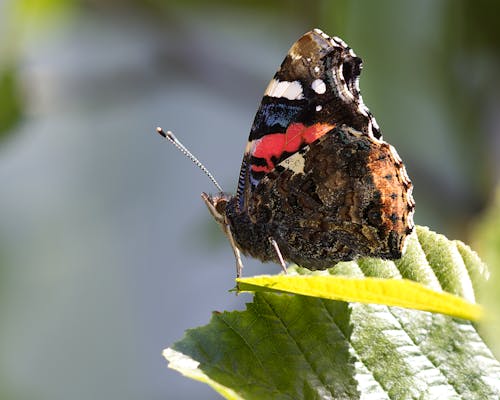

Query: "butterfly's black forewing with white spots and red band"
<box><xmin>237</xmin><ymin>29</ymin><xmax>381</xmax><ymax>210</ymax></box>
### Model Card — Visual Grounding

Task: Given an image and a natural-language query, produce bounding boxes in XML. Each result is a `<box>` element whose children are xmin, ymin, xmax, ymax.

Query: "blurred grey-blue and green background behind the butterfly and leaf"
<box><xmin>0</xmin><ymin>0</ymin><xmax>500</xmax><ymax>400</ymax></box>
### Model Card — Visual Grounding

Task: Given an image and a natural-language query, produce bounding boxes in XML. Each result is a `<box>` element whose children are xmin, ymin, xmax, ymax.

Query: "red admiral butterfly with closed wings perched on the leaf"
<box><xmin>158</xmin><ymin>29</ymin><xmax>415</xmax><ymax>276</ymax></box>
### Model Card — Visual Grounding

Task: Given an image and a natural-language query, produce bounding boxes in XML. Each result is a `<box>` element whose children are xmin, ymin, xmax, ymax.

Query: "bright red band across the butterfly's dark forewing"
<box><xmin>251</xmin><ymin>123</ymin><xmax>335</xmax><ymax>173</ymax></box>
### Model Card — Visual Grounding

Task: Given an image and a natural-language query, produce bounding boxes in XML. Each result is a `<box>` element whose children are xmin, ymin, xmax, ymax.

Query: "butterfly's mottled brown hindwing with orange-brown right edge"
<box><xmin>249</xmin><ymin>126</ymin><xmax>414</xmax><ymax>269</ymax></box>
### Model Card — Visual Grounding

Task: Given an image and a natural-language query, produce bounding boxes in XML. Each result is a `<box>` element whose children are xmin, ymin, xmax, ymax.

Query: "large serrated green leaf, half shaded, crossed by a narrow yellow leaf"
<box><xmin>164</xmin><ymin>228</ymin><xmax>500</xmax><ymax>399</ymax></box>
